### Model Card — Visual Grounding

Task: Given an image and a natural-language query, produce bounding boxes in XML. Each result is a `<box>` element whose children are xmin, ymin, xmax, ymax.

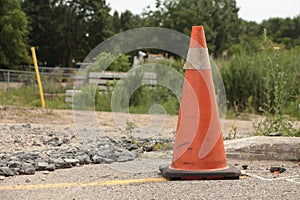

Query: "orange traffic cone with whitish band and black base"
<box><xmin>160</xmin><ymin>26</ymin><xmax>241</xmax><ymax>179</ymax></box>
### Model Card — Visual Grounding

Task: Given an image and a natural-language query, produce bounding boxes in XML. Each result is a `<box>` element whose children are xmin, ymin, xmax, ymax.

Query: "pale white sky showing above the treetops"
<box><xmin>106</xmin><ymin>0</ymin><xmax>300</xmax><ymax>23</ymax></box>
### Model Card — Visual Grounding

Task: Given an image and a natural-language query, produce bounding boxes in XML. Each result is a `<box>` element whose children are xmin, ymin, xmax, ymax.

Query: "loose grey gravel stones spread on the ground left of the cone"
<box><xmin>0</xmin><ymin>123</ymin><xmax>172</xmax><ymax>176</ymax></box>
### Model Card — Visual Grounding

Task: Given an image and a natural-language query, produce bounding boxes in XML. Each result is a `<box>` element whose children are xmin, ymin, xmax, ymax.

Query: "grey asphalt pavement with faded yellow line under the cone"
<box><xmin>0</xmin><ymin>155</ymin><xmax>300</xmax><ymax>200</ymax></box>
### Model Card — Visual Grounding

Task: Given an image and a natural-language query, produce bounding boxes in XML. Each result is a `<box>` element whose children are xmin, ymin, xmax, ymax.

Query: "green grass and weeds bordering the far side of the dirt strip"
<box><xmin>0</xmin><ymin>35</ymin><xmax>300</xmax><ymax>136</ymax></box>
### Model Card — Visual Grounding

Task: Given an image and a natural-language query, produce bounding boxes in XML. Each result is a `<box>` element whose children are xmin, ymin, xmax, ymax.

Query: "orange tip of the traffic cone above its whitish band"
<box><xmin>190</xmin><ymin>26</ymin><xmax>207</xmax><ymax>48</ymax></box>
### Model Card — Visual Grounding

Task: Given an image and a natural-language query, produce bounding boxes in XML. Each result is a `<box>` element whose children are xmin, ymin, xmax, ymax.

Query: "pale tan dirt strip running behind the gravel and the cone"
<box><xmin>0</xmin><ymin>106</ymin><xmax>300</xmax><ymax>151</ymax></box>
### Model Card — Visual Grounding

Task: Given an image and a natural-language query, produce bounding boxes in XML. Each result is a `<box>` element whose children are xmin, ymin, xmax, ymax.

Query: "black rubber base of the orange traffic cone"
<box><xmin>159</xmin><ymin>165</ymin><xmax>241</xmax><ymax>180</ymax></box>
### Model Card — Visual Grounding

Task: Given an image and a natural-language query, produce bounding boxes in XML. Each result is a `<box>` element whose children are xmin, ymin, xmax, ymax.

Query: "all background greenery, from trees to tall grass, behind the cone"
<box><xmin>0</xmin><ymin>0</ymin><xmax>300</xmax><ymax>136</ymax></box>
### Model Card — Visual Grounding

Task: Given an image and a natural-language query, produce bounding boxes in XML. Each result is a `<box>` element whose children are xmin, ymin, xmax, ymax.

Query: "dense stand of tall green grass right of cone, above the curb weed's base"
<box><xmin>220</xmin><ymin>43</ymin><xmax>300</xmax><ymax>118</ymax></box>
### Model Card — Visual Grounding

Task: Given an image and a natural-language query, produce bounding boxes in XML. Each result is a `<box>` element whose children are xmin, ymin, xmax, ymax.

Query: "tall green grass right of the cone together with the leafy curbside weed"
<box><xmin>221</xmin><ymin>30</ymin><xmax>300</xmax><ymax>136</ymax></box>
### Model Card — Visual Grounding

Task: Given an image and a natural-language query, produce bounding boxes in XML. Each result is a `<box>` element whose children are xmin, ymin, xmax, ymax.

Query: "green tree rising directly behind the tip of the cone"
<box><xmin>143</xmin><ymin>0</ymin><xmax>240</xmax><ymax>55</ymax></box>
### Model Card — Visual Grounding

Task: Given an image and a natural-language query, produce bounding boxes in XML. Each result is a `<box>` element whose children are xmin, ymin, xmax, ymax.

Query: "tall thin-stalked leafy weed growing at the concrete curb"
<box><xmin>254</xmin><ymin>31</ymin><xmax>296</xmax><ymax>136</ymax></box>
